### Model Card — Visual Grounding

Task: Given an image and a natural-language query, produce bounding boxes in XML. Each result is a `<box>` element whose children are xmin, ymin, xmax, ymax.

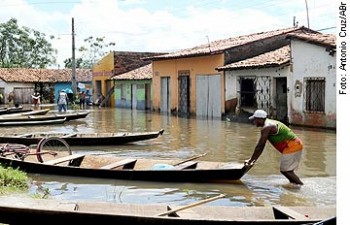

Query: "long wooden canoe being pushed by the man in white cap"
<box><xmin>0</xmin><ymin>154</ymin><xmax>251</xmax><ymax>183</ymax></box>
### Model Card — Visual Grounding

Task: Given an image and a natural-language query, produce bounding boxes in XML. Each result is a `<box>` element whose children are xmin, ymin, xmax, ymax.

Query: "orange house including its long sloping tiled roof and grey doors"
<box><xmin>148</xmin><ymin>27</ymin><xmax>312</xmax><ymax>118</ymax></box>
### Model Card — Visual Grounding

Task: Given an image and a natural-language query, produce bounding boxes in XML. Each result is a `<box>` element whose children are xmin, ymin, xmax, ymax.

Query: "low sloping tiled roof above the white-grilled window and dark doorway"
<box><xmin>217</xmin><ymin>45</ymin><xmax>290</xmax><ymax>71</ymax></box>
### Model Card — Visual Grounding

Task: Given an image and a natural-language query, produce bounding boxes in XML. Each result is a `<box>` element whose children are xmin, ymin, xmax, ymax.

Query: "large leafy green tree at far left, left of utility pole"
<box><xmin>0</xmin><ymin>18</ymin><xmax>57</xmax><ymax>68</ymax></box>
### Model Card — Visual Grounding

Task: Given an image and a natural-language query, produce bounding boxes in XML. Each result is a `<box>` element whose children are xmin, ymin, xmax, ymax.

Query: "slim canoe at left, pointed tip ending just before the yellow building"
<box><xmin>0</xmin><ymin>111</ymin><xmax>90</xmax><ymax>122</ymax></box>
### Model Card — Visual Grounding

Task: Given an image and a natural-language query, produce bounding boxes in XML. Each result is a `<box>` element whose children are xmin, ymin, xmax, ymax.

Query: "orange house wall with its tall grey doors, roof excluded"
<box><xmin>152</xmin><ymin>54</ymin><xmax>224</xmax><ymax>117</ymax></box>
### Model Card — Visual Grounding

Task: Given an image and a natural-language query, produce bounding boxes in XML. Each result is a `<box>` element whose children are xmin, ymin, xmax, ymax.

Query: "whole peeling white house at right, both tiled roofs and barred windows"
<box><xmin>218</xmin><ymin>33</ymin><xmax>336</xmax><ymax>129</ymax></box>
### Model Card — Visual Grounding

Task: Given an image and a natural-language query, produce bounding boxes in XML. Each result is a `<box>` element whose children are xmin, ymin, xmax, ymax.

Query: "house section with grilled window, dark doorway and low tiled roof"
<box><xmin>218</xmin><ymin>45</ymin><xmax>291</xmax><ymax>122</ymax></box>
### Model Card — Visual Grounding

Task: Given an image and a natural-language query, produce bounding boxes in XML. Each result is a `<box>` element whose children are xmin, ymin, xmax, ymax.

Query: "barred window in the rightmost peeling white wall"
<box><xmin>305</xmin><ymin>77</ymin><xmax>326</xmax><ymax>113</ymax></box>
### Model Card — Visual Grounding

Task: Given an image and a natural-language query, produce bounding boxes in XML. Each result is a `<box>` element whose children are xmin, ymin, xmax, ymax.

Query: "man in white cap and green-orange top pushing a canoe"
<box><xmin>246</xmin><ymin>109</ymin><xmax>303</xmax><ymax>185</ymax></box>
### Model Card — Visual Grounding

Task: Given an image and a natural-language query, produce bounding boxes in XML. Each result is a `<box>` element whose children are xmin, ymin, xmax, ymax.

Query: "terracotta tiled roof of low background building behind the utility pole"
<box><xmin>0</xmin><ymin>68</ymin><xmax>92</xmax><ymax>83</ymax></box>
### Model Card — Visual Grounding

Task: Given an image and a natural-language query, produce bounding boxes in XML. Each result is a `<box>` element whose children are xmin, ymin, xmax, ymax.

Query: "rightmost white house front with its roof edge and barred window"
<box><xmin>288</xmin><ymin>34</ymin><xmax>337</xmax><ymax>129</ymax></box>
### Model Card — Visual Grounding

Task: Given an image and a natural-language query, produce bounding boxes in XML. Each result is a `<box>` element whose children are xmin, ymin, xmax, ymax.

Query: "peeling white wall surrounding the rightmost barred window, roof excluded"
<box><xmin>288</xmin><ymin>39</ymin><xmax>336</xmax><ymax>129</ymax></box>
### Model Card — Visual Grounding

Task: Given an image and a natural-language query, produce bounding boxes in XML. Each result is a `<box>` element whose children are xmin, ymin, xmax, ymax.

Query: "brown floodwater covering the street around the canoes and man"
<box><xmin>4</xmin><ymin>108</ymin><xmax>336</xmax><ymax>206</ymax></box>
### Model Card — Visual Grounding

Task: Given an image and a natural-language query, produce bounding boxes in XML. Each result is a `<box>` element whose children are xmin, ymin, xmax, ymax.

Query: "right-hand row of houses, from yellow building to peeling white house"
<box><xmin>0</xmin><ymin>27</ymin><xmax>336</xmax><ymax>129</ymax></box>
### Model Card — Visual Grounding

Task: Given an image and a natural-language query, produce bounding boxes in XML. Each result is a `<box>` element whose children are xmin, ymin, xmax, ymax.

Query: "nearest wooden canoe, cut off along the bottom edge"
<box><xmin>0</xmin><ymin>196</ymin><xmax>336</xmax><ymax>225</ymax></box>
